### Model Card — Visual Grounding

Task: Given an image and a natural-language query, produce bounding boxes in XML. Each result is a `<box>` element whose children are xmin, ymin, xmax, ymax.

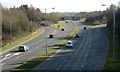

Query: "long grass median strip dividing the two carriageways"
<box><xmin>11</xmin><ymin>22</ymin><xmax>78</xmax><ymax>72</ymax></box>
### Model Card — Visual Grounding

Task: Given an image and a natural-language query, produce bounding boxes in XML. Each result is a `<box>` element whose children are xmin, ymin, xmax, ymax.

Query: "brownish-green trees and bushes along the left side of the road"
<box><xmin>2</xmin><ymin>5</ymin><xmax>58</xmax><ymax>45</ymax></box>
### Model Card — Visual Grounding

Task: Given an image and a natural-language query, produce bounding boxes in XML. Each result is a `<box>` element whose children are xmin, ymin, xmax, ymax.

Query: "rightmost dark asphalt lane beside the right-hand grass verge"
<box><xmin>83</xmin><ymin>28</ymin><xmax>108</xmax><ymax>70</ymax></box>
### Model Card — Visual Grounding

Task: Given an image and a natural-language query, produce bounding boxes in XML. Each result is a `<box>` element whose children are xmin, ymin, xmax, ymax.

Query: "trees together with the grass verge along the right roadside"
<box><xmin>75</xmin><ymin>5</ymin><xmax>120</xmax><ymax>70</ymax></box>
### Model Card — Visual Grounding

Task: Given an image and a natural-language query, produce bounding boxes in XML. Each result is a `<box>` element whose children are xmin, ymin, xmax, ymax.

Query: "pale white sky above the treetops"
<box><xmin>0</xmin><ymin>0</ymin><xmax>120</xmax><ymax>12</ymax></box>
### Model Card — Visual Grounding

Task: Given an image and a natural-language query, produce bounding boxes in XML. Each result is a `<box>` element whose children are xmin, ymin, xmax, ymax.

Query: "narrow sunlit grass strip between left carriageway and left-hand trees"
<box><xmin>0</xmin><ymin>29</ymin><xmax>43</xmax><ymax>52</ymax></box>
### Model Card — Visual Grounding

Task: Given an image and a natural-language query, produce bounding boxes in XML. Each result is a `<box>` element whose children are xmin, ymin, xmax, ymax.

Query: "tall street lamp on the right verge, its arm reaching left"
<box><xmin>102</xmin><ymin>4</ymin><xmax>116</xmax><ymax>63</ymax></box>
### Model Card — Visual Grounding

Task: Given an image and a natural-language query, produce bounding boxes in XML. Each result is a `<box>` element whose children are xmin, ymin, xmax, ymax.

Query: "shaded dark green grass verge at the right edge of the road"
<box><xmin>103</xmin><ymin>29</ymin><xmax>120</xmax><ymax>70</ymax></box>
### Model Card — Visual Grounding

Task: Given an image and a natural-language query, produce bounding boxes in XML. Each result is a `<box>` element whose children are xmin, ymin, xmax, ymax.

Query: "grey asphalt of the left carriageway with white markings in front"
<box><xmin>0</xmin><ymin>22</ymin><xmax>73</xmax><ymax>71</ymax></box>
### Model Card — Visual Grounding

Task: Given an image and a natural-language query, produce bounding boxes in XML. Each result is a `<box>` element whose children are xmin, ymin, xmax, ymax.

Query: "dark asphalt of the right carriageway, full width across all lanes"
<box><xmin>31</xmin><ymin>22</ymin><xmax>108</xmax><ymax>72</ymax></box>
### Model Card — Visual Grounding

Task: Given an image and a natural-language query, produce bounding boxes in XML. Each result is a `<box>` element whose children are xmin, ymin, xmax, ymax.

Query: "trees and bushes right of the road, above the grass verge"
<box><xmin>75</xmin><ymin>5</ymin><xmax>120</xmax><ymax>41</ymax></box>
